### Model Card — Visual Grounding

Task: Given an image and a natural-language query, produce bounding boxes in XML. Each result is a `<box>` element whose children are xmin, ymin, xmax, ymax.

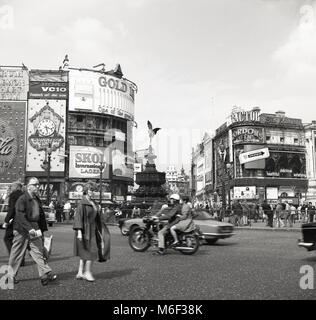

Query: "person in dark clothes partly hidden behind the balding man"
<box><xmin>3</xmin><ymin>181</ymin><xmax>23</xmax><ymax>254</ymax></box>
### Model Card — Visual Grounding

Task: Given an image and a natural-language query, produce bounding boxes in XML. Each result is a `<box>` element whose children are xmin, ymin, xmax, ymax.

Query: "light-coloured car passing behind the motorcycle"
<box><xmin>118</xmin><ymin>210</ymin><xmax>235</xmax><ymax>244</ymax></box>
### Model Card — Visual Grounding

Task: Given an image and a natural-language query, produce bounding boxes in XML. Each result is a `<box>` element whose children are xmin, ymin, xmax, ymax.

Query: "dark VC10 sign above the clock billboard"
<box><xmin>29</xmin><ymin>81</ymin><xmax>68</xmax><ymax>99</ymax></box>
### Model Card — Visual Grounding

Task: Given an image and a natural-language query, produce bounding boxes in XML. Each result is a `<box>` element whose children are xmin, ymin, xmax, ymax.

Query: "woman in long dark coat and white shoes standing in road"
<box><xmin>73</xmin><ymin>184</ymin><xmax>110</xmax><ymax>281</ymax></box>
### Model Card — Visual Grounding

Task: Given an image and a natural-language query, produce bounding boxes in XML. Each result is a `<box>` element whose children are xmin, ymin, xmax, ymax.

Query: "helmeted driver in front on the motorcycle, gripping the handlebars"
<box><xmin>153</xmin><ymin>193</ymin><xmax>181</xmax><ymax>255</ymax></box>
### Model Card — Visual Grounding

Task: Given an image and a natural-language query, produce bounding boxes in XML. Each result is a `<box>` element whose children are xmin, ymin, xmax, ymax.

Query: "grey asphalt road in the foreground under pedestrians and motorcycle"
<box><xmin>0</xmin><ymin>225</ymin><xmax>316</xmax><ymax>300</ymax></box>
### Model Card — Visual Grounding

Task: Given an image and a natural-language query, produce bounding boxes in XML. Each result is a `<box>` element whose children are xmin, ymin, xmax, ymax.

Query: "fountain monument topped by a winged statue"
<box><xmin>135</xmin><ymin>121</ymin><xmax>167</xmax><ymax>205</ymax></box>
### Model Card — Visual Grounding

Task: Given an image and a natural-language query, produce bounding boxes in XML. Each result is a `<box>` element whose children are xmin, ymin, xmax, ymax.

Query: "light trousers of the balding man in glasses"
<box><xmin>9</xmin><ymin>230</ymin><xmax>52</xmax><ymax>278</ymax></box>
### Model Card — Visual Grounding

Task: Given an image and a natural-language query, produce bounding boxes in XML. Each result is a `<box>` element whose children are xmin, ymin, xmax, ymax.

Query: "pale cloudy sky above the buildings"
<box><xmin>0</xmin><ymin>0</ymin><xmax>316</xmax><ymax>172</ymax></box>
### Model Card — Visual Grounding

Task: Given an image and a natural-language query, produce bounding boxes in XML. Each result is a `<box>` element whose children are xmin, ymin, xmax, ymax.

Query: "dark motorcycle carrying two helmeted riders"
<box><xmin>129</xmin><ymin>217</ymin><xmax>200</xmax><ymax>255</ymax></box>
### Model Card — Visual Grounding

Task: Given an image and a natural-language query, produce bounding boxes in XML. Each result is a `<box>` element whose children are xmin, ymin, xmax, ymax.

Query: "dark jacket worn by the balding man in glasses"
<box><xmin>13</xmin><ymin>191</ymin><xmax>47</xmax><ymax>235</ymax></box>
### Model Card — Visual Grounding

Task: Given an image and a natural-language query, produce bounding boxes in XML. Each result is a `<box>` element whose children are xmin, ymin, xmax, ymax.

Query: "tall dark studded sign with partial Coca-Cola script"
<box><xmin>0</xmin><ymin>101</ymin><xmax>26</xmax><ymax>183</ymax></box>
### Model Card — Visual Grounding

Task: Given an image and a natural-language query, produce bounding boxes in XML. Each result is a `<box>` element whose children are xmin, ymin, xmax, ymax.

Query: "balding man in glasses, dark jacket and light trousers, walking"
<box><xmin>9</xmin><ymin>177</ymin><xmax>57</xmax><ymax>285</ymax></box>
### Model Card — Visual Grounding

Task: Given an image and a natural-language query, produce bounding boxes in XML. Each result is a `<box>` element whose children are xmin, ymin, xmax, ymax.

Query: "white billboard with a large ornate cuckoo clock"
<box><xmin>26</xmin><ymin>99</ymin><xmax>66</xmax><ymax>172</ymax></box>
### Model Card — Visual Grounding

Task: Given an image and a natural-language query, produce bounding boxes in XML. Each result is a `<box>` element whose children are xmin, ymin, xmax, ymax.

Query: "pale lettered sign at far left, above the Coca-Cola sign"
<box><xmin>0</xmin><ymin>67</ymin><xmax>29</xmax><ymax>100</ymax></box>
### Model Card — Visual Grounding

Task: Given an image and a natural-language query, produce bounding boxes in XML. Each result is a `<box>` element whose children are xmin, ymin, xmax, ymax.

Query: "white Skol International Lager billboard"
<box><xmin>69</xmin><ymin>146</ymin><xmax>109</xmax><ymax>179</ymax></box>
